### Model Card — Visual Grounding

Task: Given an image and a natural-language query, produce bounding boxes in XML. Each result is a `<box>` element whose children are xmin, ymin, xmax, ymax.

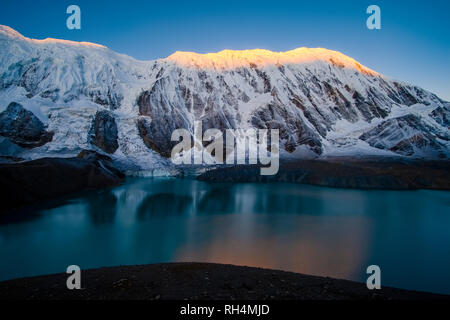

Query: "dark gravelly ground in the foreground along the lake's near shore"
<box><xmin>0</xmin><ymin>263</ymin><xmax>444</xmax><ymax>300</ymax></box>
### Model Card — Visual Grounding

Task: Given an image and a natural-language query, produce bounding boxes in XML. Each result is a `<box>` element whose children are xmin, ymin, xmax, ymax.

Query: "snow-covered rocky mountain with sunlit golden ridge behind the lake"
<box><xmin>0</xmin><ymin>26</ymin><xmax>450</xmax><ymax>174</ymax></box>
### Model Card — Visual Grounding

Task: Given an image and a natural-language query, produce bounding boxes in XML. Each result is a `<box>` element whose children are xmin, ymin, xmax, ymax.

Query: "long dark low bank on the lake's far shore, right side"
<box><xmin>198</xmin><ymin>157</ymin><xmax>450</xmax><ymax>190</ymax></box>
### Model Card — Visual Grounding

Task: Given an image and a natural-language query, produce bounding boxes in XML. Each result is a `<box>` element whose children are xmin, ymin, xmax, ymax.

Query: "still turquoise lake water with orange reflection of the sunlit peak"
<box><xmin>0</xmin><ymin>178</ymin><xmax>450</xmax><ymax>294</ymax></box>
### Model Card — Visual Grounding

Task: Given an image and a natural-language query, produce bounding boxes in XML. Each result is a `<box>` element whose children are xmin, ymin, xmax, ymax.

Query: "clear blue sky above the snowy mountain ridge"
<box><xmin>0</xmin><ymin>0</ymin><xmax>450</xmax><ymax>100</ymax></box>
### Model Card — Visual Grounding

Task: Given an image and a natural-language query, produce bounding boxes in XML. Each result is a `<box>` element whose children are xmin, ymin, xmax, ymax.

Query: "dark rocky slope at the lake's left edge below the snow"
<box><xmin>0</xmin><ymin>151</ymin><xmax>124</xmax><ymax>213</ymax></box>
